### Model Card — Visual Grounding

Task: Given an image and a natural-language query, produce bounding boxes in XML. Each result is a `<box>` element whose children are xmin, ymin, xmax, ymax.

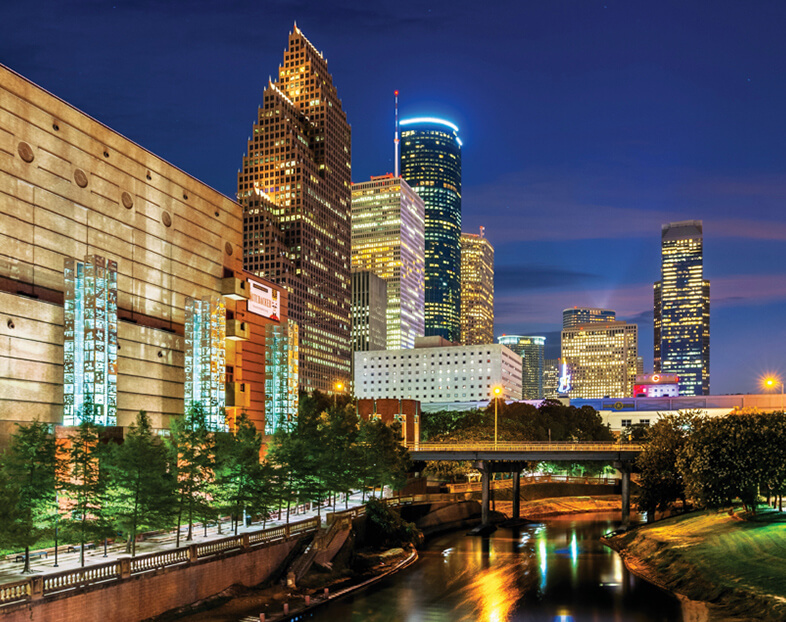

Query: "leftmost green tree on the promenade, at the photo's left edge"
<box><xmin>4</xmin><ymin>420</ymin><xmax>62</xmax><ymax>573</ymax></box>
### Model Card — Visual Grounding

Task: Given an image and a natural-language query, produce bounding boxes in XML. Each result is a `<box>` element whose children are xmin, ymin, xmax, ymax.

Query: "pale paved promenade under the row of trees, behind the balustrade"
<box><xmin>0</xmin><ymin>492</ymin><xmax>363</xmax><ymax>585</ymax></box>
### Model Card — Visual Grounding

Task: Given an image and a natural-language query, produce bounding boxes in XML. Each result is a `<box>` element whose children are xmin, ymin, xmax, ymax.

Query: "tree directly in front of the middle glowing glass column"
<box><xmin>169</xmin><ymin>404</ymin><xmax>215</xmax><ymax>546</ymax></box>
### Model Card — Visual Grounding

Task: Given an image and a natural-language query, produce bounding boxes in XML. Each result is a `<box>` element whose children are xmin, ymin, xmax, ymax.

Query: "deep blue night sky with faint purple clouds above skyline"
<box><xmin>0</xmin><ymin>0</ymin><xmax>786</xmax><ymax>394</ymax></box>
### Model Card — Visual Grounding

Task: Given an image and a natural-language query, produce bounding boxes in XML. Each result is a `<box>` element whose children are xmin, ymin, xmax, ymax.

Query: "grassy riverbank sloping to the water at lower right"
<box><xmin>604</xmin><ymin>508</ymin><xmax>786</xmax><ymax>622</ymax></box>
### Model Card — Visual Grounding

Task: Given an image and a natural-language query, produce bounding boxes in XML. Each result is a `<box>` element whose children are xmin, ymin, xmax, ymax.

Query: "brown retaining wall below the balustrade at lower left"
<box><xmin>2</xmin><ymin>538</ymin><xmax>298</xmax><ymax>622</ymax></box>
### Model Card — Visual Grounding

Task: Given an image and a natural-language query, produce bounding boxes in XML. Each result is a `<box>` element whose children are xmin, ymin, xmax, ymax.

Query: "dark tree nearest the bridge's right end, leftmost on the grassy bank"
<box><xmin>636</xmin><ymin>411</ymin><xmax>705</xmax><ymax>520</ymax></box>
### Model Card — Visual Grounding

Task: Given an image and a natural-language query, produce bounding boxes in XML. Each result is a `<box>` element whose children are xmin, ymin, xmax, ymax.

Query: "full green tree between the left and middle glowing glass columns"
<box><xmin>107</xmin><ymin>411</ymin><xmax>174</xmax><ymax>556</ymax></box>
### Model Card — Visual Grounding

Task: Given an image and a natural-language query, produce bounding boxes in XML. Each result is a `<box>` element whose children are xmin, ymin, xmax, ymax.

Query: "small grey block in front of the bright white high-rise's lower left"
<box><xmin>351</xmin><ymin>270</ymin><xmax>386</xmax><ymax>352</ymax></box>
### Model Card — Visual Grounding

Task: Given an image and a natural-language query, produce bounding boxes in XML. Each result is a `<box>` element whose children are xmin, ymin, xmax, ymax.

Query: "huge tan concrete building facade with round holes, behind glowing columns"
<box><xmin>0</xmin><ymin>66</ymin><xmax>287</xmax><ymax>443</ymax></box>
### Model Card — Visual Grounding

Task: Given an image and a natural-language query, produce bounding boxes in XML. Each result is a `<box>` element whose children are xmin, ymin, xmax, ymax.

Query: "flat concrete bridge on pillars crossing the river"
<box><xmin>407</xmin><ymin>442</ymin><xmax>642</xmax><ymax>527</ymax></box>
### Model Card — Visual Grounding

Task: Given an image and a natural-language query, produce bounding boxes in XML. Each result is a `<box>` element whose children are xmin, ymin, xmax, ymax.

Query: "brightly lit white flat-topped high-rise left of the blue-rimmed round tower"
<box><xmin>352</xmin><ymin>174</ymin><xmax>425</xmax><ymax>350</ymax></box>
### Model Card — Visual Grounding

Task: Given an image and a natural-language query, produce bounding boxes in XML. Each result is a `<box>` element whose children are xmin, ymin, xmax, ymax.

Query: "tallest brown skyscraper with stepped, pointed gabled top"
<box><xmin>238</xmin><ymin>26</ymin><xmax>351</xmax><ymax>391</ymax></box>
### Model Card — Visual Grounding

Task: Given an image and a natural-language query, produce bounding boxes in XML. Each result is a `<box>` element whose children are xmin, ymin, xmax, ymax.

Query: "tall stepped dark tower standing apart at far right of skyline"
<box><xmin>653</xmin><ymin>220</ymin><xmax>710</xmax><ymax>395</ymax></box>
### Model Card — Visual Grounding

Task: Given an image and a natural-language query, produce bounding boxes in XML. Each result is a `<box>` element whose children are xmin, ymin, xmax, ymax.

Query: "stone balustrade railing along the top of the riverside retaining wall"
<box><xmin>0</xmin><ymin>518</ymin><xmax>320</xmax><ymax>611</ymax></box>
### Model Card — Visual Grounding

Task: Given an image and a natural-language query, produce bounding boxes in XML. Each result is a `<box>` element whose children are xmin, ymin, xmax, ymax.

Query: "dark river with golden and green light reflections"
<box><xmin>306</xmin><ymin>513</ymin><xmax>682</xmax><ymax>622</ymax></box>
